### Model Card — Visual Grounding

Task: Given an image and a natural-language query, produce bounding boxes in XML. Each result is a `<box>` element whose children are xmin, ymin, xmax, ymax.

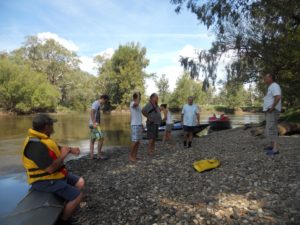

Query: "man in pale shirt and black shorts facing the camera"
<box><xmin>181</xmin><ymin>96</ymin><xmax>200</xmax><ymax>148</ymax></box>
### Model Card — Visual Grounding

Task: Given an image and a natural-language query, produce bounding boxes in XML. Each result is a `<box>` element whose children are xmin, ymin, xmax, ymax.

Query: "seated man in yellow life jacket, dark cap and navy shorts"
<box><xmin>22</xmin><ymin>114</ymin><xmax>84</xmax><ymax>224</ymax></box>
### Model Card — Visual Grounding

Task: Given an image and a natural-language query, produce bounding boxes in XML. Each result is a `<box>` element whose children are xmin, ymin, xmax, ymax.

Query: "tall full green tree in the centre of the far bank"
<box><xmin>95</xmin><ymin>43</ymin><xmax>149</xmax><ymax>106</ymax></box>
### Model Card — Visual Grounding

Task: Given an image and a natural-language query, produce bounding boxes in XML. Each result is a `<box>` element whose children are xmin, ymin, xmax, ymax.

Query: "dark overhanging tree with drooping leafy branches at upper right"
<box><xmin>171</xmin><ymin>0</ymin><xmax>300</xmax><ymax>105</ymax></box>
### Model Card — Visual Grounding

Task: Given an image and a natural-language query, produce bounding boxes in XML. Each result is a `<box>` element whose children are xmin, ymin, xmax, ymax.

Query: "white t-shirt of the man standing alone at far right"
<box><xmin>263</xmin><ymin>82</ymin><xmax>281</xmax><ymax>112</ymax></box>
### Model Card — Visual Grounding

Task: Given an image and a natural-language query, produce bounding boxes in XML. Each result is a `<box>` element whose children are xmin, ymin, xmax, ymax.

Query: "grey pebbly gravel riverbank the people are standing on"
<box><xmin>67</xmin><ymin>128</ymin><xmax>300</xmax><ymax>225</ymax></box>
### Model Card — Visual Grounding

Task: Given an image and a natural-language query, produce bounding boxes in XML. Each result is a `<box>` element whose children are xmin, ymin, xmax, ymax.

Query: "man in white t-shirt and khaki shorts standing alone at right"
<box><xmin>263</xmin><ymin>73</ymin><xmax>281</xmax><ymax>155</ymax></box>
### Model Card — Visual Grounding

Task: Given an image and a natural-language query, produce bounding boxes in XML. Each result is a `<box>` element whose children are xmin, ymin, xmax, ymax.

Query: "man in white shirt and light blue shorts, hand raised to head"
<box><xmin>129</xmin><ymin>92</ymin><xmax>143</xmax><ymax>162</ymax></box>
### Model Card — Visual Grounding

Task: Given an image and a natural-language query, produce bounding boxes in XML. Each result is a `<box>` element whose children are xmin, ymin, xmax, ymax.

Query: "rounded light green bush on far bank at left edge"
<box><xmin>0</xmin><ymin>59</ymin><xmax>60</xmax><ymax>113</ymax></box>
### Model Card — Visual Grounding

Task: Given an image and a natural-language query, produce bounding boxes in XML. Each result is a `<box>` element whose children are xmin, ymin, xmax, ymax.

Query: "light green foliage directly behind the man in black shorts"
<box><xmin>169</xmin><ymin>73</ymin><xmax>211</xmax><ymax>108</ymax></box>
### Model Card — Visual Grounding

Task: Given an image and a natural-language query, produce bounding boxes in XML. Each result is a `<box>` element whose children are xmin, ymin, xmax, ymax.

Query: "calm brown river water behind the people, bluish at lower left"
<box><xmin>0</xmin><ymin>113</ymin><xmax>263</xmax><ymax>216</ymax></box>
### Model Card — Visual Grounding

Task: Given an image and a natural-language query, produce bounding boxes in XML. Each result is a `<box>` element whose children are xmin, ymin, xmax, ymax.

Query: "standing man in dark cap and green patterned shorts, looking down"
<box><xmin>89</xmin><ymin>95</ymin><xmax>109</xmax><ymax>159</ymax></box>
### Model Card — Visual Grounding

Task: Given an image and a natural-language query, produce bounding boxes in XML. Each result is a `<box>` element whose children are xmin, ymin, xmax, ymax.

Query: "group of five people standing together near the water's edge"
<box><xmin>90</xmin><ymin>92</ymin><xmax>200</xmax><ymax>162</ymax></box>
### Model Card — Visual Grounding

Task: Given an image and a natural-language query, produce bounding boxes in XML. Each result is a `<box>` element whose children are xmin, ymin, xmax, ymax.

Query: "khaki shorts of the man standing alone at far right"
<box><xmin>265</xmin><ymin>110</ymin><xmax>280</xmax><ymax>141</ymax></box>
